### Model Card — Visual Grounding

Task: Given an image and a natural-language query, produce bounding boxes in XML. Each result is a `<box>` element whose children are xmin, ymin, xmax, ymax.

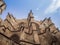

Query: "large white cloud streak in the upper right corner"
<box><xmin>45</xmin><ymin>0</ymin><xmax>60</xmax><ymax>14</ymax></box>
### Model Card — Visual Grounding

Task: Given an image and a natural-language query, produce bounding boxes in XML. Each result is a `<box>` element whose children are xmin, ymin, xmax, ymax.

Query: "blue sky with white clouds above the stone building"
<box><xmin>0</xmin><ymin>0</ymin><xmax>60</xmax><ymax>29</ymax></box>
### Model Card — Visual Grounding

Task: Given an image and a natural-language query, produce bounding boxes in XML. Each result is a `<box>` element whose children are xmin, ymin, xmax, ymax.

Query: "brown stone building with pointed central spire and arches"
<box><xmin>0</xmin><ymin>11</ymin><xmax>60</xmax><ymax>45</ymax></box>
